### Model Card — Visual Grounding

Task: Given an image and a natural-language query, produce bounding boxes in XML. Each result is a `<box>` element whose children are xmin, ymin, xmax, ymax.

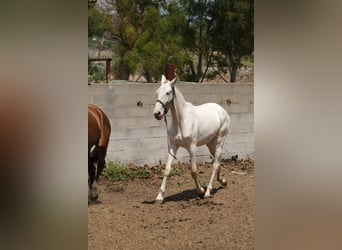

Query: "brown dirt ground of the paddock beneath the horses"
<box><xmin>88</xmin><ymin>159</ymin><xmax>254</xmax><ymax>250</ymax></box>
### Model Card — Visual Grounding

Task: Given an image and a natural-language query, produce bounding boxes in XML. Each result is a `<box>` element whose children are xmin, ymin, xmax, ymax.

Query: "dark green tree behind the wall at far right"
<box><xmin>210</xmin><ymin>0</ymin><xmax>254</xmax><ymax>82</ymax></box>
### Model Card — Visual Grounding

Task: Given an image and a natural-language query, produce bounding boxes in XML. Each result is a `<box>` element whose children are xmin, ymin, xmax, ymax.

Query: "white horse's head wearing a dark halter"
<box><xmin>153</xmin><ymin>75</ymin><xmax>176</xmax><ymax>120</ymax></box>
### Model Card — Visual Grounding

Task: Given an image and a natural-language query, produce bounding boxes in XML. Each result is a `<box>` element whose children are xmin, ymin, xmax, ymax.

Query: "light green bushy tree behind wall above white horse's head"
<box><xmin>125</xmin><ymin>1</ymin><xmax>190</xmax><ymax>82</ymax></box>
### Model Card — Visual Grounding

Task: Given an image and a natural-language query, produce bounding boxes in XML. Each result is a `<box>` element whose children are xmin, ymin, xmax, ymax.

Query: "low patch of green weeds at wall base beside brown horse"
<box><xmin>103</xmin><ymin>162</ymin><xmax>150</xmax><ymax>181</ymax></box>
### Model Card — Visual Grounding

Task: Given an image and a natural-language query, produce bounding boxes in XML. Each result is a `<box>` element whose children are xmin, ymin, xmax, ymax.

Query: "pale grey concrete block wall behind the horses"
<box><xmin>88</xmin><ymin>81</ymin><xmax>254</xmax><ymax>166</ymax></box>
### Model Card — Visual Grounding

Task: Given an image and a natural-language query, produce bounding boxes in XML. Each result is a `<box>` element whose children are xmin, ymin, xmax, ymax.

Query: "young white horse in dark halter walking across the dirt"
<box><xmin>153</xmin><ymin>75</ymin><xmax>230</xmax><ymax>201</ymax></box>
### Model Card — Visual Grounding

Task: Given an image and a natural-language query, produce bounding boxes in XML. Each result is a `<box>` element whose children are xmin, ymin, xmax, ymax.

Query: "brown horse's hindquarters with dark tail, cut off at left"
<box><xmin>88</xmin><ymin>104</ymin><xmax>111</xmax><ymax>201</ymax></box>
